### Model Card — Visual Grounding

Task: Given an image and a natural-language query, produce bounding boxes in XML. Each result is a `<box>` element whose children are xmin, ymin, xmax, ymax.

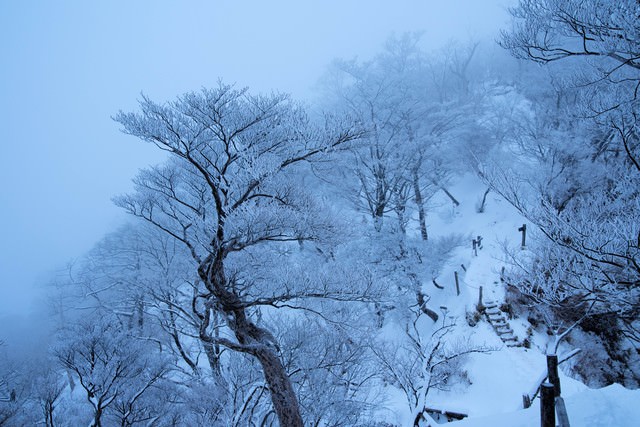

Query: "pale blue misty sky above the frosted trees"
<box><xmin>0</xmin><ymin>0</ymin><xmax>513</xmax><ymax>316</ymax></box>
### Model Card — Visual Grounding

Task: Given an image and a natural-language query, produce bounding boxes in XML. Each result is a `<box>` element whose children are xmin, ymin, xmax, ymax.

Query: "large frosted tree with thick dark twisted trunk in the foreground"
<box><xmin>116</xmin><ymin>84</ymin><xmax>368</xmax><ymax>426</ymax></box>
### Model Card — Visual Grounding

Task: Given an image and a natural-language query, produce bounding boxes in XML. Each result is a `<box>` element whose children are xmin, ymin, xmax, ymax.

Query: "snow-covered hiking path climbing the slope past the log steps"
<box><xmin>416</xmin><ymin>176</ymin><xmax>587</xmax><ymax>425</ymax></box>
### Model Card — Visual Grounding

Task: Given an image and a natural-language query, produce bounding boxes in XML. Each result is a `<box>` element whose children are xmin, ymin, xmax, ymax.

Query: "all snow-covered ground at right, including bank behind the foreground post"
<box><xmin>399</xmin><ymin>176</ymin><xmax>640</xmax><ymax>427</ymax></box>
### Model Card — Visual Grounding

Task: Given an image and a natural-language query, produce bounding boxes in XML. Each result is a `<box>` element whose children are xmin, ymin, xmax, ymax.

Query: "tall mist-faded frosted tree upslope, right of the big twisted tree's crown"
<box><xmin>323</xmin><ymin>34</ymin><xmax>488</xmax><ymax>240</ymax></box>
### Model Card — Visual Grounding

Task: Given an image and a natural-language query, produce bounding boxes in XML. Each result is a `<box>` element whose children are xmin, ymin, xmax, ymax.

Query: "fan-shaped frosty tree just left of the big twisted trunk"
<box><xmin>66</xmin><ymin>222</ymin><xmax>214</xmax><ymax>375</ymax></box>
